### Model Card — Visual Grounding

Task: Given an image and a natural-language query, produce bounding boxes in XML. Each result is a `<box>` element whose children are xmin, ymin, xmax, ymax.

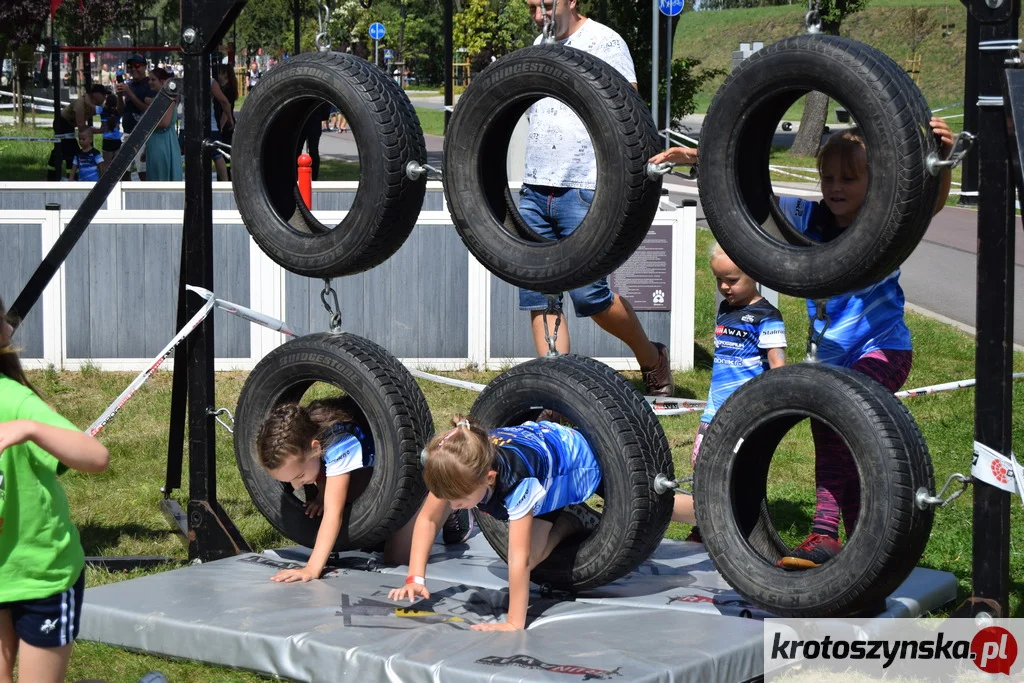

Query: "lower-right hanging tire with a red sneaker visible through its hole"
<box><xmin>694</xmin><ymin>364</ymin><xmax>935</xmax><ymax>616</ymax></box>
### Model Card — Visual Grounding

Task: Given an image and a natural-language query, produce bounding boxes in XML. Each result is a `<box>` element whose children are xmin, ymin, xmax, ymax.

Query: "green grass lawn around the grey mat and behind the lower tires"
<box><xmin>18</xmin><ymin>230</ymin><xmax>1024</xmax><ymax>683</ymax></box>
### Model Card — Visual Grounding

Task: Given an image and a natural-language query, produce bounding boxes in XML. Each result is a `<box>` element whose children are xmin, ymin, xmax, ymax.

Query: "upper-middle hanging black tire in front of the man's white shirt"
<box><xmin>444</xmin><ymin>45</ymin><xmax>662</xmax><ymax>293</ymax></box>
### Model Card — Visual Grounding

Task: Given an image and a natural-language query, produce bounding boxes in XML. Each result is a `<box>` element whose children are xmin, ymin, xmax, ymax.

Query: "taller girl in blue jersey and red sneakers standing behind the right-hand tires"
<box><xmin>778</xmin><ymin>117</ymin><xmax>953</xmax><ymax>569</ymax></box>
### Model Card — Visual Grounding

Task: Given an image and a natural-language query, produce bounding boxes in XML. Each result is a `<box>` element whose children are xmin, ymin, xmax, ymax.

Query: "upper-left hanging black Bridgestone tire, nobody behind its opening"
<box><xmin>231</xmin><ymin>52</ymin><xmax>427</xmax><ymax>278</ymax></box>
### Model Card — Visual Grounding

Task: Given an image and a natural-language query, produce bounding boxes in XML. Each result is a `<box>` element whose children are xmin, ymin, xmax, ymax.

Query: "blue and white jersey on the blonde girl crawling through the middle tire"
<box><xmin>477</xmin><ymin>422</ymin><xmax>601</xmax><ymax>520</ymax></box>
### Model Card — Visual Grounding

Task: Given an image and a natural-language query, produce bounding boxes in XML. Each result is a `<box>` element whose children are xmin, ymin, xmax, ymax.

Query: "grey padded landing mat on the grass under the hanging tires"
<box><xmin>81</xmin><ymin>536</ymin><xmax>956</xmax><ymax>683</ymax></box>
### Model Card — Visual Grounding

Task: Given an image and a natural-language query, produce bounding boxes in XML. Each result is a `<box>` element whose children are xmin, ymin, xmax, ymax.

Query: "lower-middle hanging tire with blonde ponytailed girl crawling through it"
<box><xmin>472</xmin><ymin>355</ymin><xmax>673</xmax><ymax>592</ymax></box>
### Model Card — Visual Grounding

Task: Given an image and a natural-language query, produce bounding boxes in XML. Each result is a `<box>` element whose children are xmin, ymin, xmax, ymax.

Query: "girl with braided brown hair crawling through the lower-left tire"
<box><xmin>256</xmin><ymin>396</ymin><xmax>464</xmax><ymax>583</ymax></box>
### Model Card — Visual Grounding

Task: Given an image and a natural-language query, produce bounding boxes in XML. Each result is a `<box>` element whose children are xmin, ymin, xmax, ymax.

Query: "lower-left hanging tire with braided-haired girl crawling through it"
<box><xmin>234</xmin><ymin>333</ymin><xmax>433</xmax><ymax>551</ymax></box>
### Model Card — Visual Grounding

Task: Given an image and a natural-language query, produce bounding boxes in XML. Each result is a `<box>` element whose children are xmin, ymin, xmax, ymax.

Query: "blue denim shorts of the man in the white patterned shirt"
<box><xmin>519</xmin><ymin>185</ymin><xmax>615</xmax><ymax>317</ymax></box>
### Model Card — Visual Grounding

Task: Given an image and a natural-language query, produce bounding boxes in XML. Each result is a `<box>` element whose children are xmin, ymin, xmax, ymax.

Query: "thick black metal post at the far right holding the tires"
<box><xmin>956</xmin><ymin>0</ymin><xmax>1020</xmax><ymax>617</ymax></box>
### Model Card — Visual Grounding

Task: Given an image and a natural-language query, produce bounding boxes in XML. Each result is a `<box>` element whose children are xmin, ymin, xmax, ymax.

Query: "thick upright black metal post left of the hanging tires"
<box><xmin>174</xmin><ymin>0</ymin><xmax>249</xmax><ymax>561</ymax></box>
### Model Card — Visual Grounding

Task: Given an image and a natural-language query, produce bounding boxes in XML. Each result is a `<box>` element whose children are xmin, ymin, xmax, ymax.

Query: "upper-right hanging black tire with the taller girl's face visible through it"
<box><xmin>699</xmin><ymin>35</ymin><xmax>939</xmax><ymax>298</ymax></box>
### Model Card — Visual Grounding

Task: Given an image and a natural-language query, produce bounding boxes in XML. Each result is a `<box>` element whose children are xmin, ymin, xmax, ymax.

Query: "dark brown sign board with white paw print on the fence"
<box><xmin>608</xmin><ymin>223</ymin><xmax>672</xmax><ymax>311</ymax></box>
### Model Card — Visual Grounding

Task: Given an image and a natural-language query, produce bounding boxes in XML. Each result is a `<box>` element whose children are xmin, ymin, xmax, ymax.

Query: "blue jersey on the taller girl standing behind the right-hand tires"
<box><xmin>779</xmin><ymin>197</ymin><xmax>912</xmax><ymax>368</ymax></box>
